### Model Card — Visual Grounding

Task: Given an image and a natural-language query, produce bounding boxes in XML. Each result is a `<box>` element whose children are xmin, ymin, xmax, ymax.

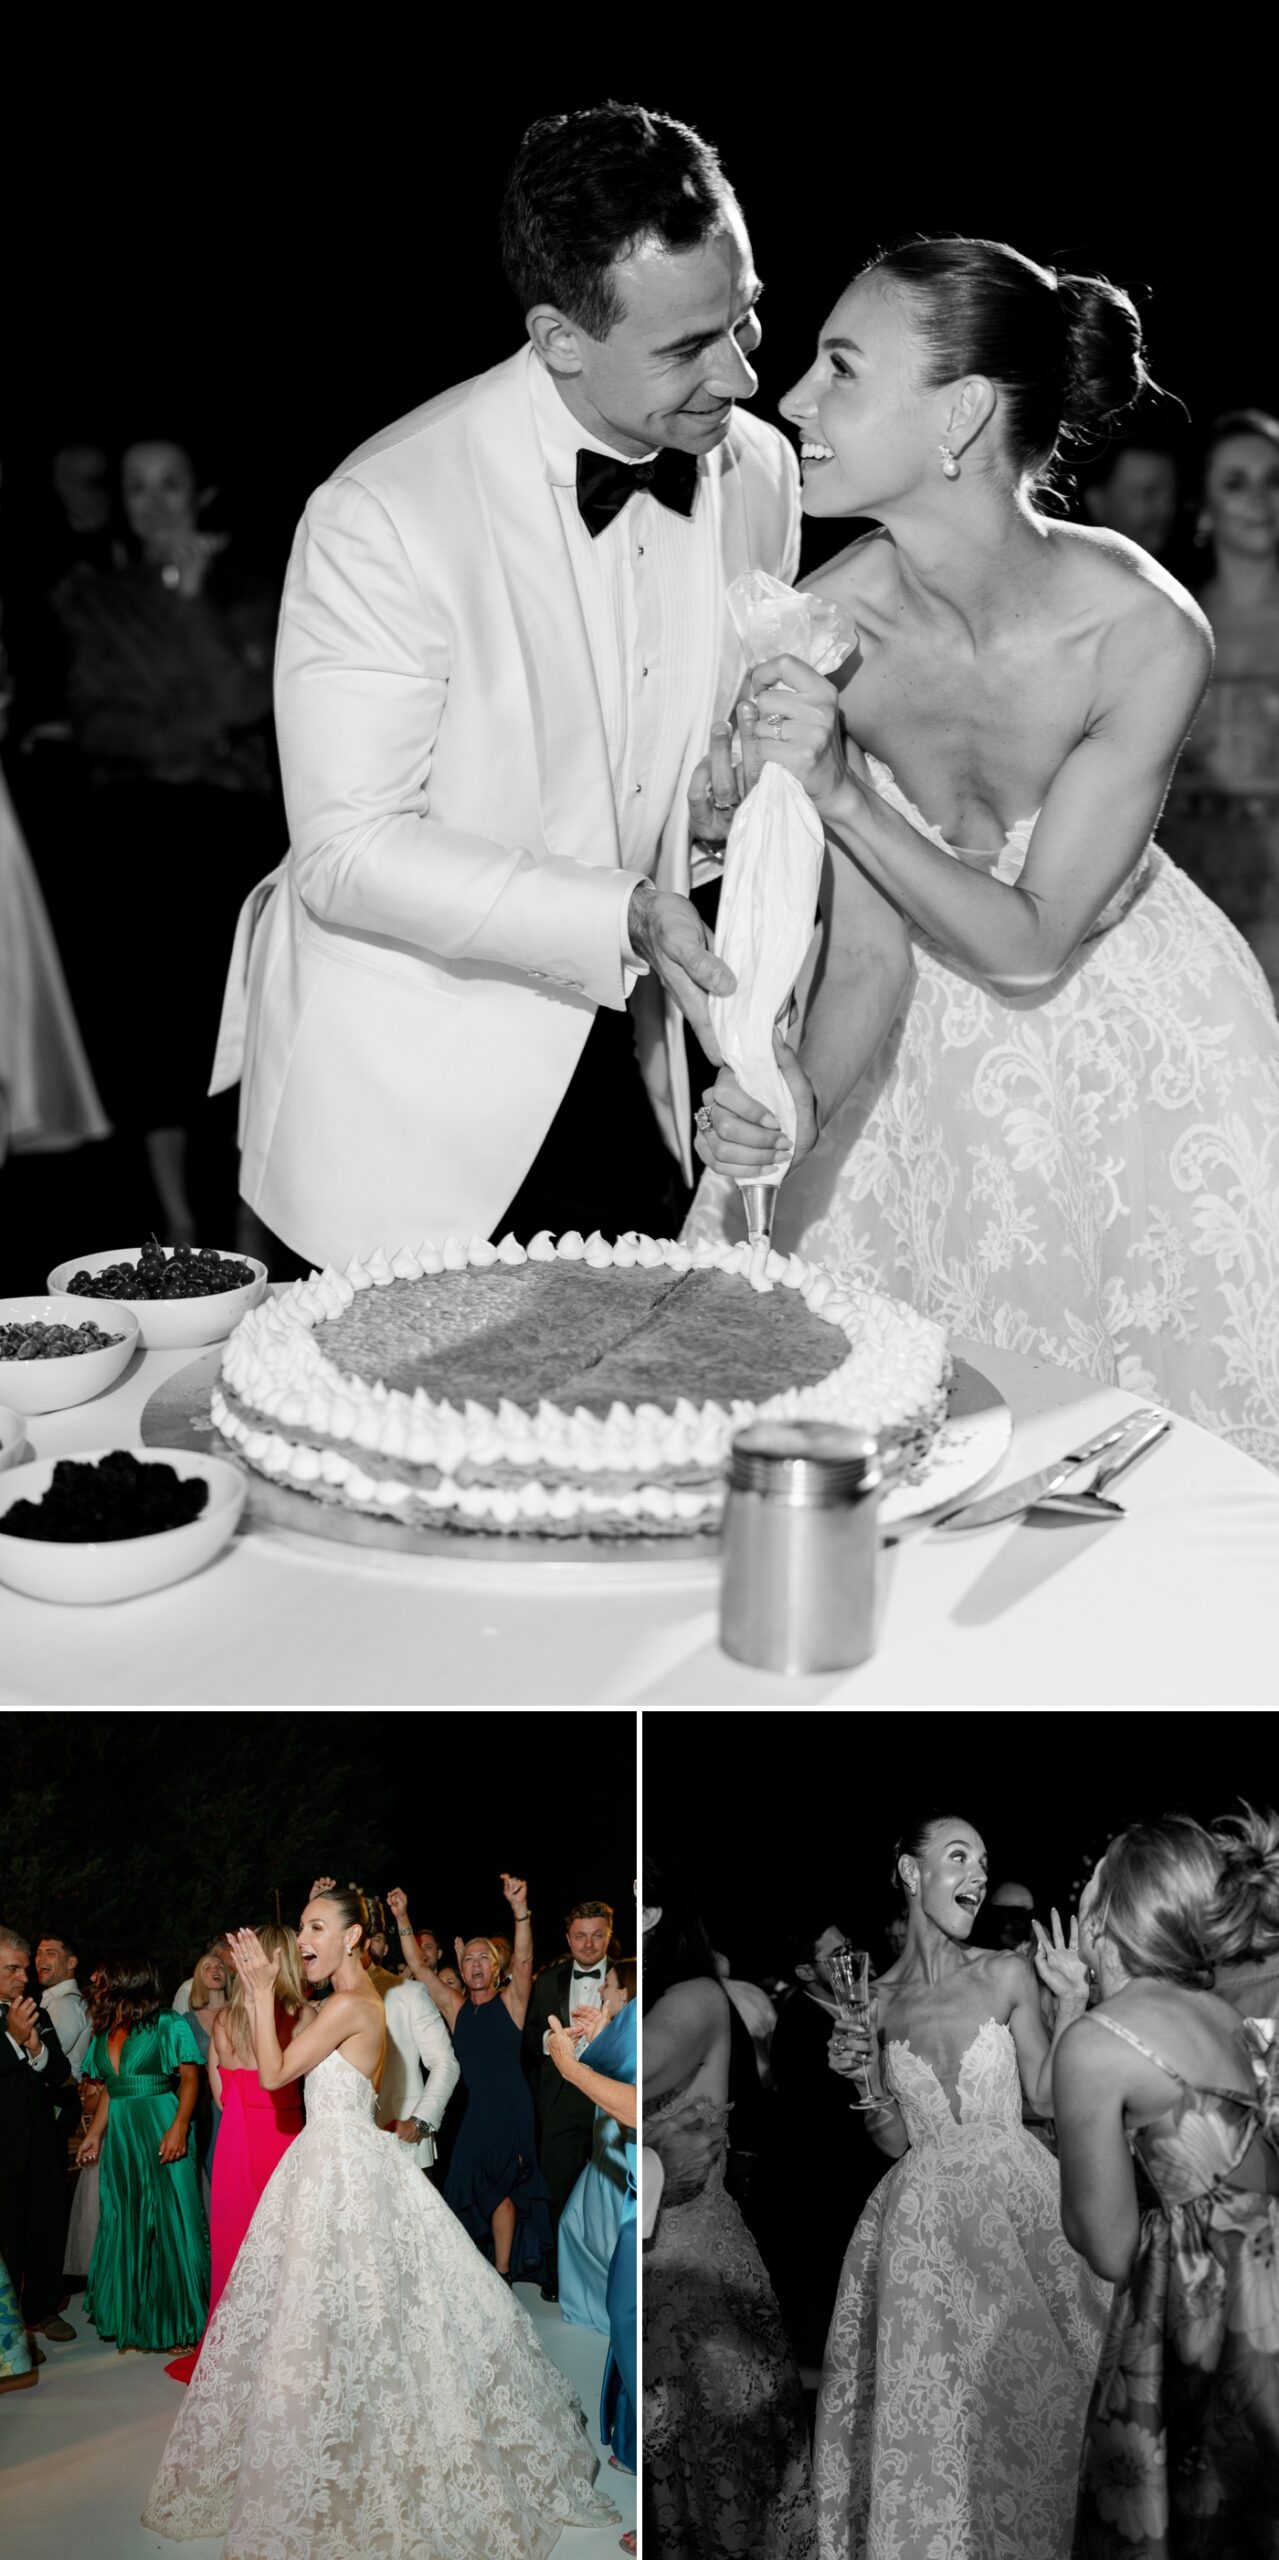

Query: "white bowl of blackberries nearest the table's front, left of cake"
<box><xmin>0</xmin><ymin>1449</ymin><xmax>248</xmax><ymax>1603</ymax></box>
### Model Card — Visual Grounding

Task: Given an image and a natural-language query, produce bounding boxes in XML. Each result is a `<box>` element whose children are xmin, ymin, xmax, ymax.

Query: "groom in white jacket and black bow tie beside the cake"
<box><xmin>212</xmin><ymin>108</ymin><xmax>801</xmax><ymax>1265</ymax></box>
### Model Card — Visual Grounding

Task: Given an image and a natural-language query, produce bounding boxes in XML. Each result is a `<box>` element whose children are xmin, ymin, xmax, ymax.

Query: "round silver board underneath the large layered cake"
<box><xmin>143</xmin><ymin>1344</ymin><xmax>1013</xmax><ymax>1572</ymax></box>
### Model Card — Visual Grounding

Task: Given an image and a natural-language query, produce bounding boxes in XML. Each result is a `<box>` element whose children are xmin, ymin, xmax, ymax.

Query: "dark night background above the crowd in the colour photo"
<box><xmin>0</xmin><ymin>1710</ymin><xmax>637</xmax><ymax>1999</ymax></box>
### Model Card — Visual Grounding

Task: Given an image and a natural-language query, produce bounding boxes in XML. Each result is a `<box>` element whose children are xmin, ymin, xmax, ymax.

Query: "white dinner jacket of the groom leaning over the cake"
<box><xmin>212</xmin><ymin>348</ymin><xmax>798</xmax><ymax>1267</ymax></box>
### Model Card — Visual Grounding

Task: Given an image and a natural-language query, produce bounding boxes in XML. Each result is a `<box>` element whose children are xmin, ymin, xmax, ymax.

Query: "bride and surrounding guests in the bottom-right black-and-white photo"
<box><xmin>642</xmin><ymin>1805</ymin><xmax>1279</xmax><ymax>2560</ymax></box>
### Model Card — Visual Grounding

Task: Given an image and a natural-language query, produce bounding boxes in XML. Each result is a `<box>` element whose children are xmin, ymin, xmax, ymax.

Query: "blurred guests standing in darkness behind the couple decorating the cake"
<box><xmin>0</xmin><ymin>404</ymin><xmax>1279</xmax><ymax>1285</ymax></box>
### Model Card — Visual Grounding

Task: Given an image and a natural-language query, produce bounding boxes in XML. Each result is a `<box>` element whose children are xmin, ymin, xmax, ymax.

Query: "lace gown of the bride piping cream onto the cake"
<box><xmin>686</xmin><ymin>758</ymin><xmax>1279</xmax><ymax>1467</ymax></box>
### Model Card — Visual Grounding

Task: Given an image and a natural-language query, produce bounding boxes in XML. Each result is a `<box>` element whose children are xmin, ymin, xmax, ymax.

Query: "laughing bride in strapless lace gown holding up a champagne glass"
<box><xmin>813</xmin><ymin>1815</ymin><xmax>1110</xmax><ymax>2560</ymax></box>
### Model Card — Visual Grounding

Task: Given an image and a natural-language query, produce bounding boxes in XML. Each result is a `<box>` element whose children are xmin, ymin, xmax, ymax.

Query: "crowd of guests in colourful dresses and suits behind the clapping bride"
<box><xmin>0</xmin><ymin>1876</ymin><xmax>637</xmax><ymax>2539</ymax></box>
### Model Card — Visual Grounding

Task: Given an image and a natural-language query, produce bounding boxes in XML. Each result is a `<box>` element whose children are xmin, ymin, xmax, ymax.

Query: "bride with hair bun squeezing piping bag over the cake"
<box><xmin>686</xmin><ymin>241</ymin><xmax>1279</xmax><ymax>1467</ymax></box>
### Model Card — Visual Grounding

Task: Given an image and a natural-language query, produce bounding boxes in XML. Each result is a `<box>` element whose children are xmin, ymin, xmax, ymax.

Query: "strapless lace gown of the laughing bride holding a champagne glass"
<box><xmin>813</xmin><ymin>2017</ymin><xmax>1110</xmax><ymax>2560</ymax></box>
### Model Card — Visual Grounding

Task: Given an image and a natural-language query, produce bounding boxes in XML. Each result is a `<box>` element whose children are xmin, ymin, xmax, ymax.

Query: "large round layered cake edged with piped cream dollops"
<box><xmin>212</xmin><ymin>1234</ymin><xmax>949</xmax><ymax>1539</ymax></box>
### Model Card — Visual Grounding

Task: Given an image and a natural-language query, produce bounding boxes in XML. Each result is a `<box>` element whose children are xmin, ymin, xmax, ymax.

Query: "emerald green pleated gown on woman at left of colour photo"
<box><xmin>82</xmin><ymin>2010</ymin><xmax>210</xmax><ymax>2348</ymax></box>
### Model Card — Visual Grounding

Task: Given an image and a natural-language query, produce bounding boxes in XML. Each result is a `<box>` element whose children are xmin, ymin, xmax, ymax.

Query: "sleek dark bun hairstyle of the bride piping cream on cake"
<box><xmin>862</xmin><ymin>238</ymin><xmax>1151</xmax><ymax>476</ymax></box>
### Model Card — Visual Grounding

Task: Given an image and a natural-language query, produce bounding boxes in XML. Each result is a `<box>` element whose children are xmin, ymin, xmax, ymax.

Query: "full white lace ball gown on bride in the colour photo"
<box><xmin>143</xmin><ymin>2053</ymin><xmax>616</xmax><ymax>2560</ymax></box>
